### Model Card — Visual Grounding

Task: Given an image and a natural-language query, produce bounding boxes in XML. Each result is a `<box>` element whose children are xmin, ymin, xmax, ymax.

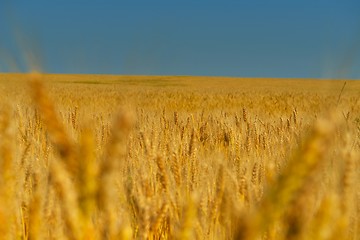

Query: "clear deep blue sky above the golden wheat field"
<box><xmin>0</xmin><ymin>0</ymin><xmax>360</xmax><ymax>79</ymax></box>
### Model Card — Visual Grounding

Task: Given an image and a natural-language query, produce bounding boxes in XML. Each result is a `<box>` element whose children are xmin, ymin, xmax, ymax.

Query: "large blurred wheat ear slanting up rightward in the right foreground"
<box><xmin>236</xmin><ymin>116</ymin><xmax>342</xmax><ymax>239</ymax></box>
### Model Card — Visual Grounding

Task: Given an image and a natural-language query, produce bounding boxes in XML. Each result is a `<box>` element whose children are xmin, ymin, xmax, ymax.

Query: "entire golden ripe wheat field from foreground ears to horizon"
<box><xmin>0</xmin><ymin>74</ymin><xmax>360</xmax><ymax>240</ymax></box>
